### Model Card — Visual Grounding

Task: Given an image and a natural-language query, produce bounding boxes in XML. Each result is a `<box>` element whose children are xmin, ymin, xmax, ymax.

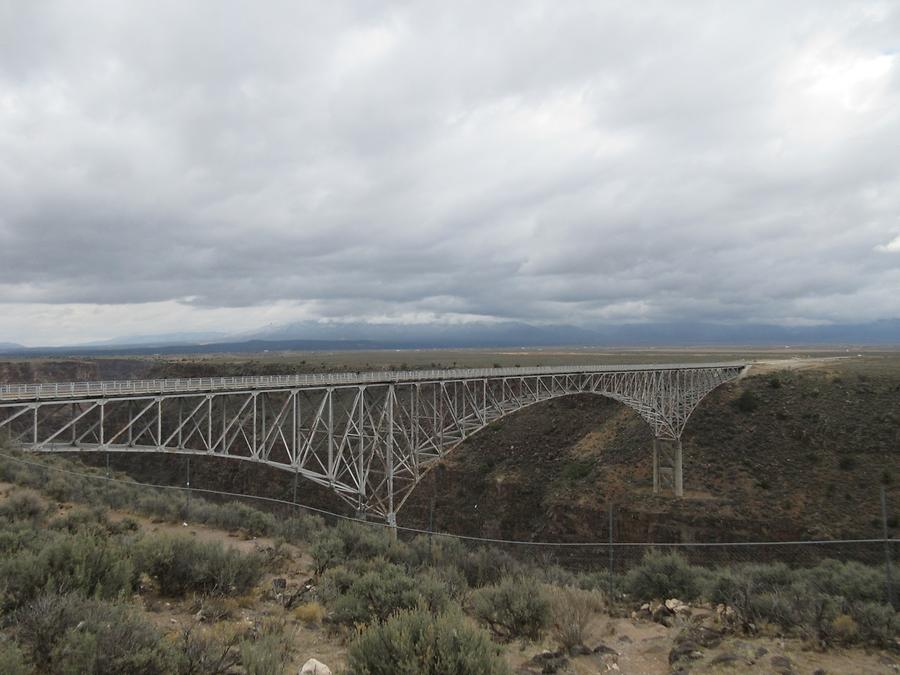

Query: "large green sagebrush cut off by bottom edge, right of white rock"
<box><xmin>347</xmin><ymin>610</ymin><xmax>509</xmax><ymax>675</ymax></box>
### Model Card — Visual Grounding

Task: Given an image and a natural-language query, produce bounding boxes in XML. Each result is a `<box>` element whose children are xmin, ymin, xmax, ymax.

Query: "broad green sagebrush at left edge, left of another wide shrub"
<box><xmin>0</xmin><ymin>532</ymin><xmax>136</xmax><ymax>610</ymax></box>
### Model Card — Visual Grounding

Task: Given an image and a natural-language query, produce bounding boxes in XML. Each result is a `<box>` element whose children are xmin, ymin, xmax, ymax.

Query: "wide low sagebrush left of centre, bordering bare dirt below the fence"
<box><xmin>136</xmin><ymin>535</ymin><xmax>264</xmax><ymax>597</ymax></box>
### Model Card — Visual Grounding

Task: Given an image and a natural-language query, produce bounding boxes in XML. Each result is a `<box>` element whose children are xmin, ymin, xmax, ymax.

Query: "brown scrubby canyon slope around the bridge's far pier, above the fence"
<box><xmin>403</xmin><ymin>361</ymin><xmax>900</xmax><ymax>541</ymax></box>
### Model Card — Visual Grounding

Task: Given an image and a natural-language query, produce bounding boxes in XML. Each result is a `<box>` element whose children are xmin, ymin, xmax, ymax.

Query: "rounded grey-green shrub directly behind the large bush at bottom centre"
<box><xmin>331</xmin><ymin>563</ymin><xmax>430</xmax><ymax>626</ymax></box>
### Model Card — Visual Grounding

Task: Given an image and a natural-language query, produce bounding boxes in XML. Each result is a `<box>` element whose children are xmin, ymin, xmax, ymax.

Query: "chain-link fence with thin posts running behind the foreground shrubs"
<box><xmin>0</xmin><ymin>451</ymin><xmax>900</xmax><ymax>608</ymax></box>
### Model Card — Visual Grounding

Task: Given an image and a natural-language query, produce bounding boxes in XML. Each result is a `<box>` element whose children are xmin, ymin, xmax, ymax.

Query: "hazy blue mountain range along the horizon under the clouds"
<box><xmin>0</xmin><ymin>319</ymin><xmax>900</xmax><ymax>356</ymax></box>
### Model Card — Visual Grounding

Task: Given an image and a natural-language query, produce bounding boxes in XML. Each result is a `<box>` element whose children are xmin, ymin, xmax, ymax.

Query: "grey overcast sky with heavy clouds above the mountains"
<box><xmin>0</xmin><ymin>0</ymin><xmax>900</xmax><ymax>345</ymax></box>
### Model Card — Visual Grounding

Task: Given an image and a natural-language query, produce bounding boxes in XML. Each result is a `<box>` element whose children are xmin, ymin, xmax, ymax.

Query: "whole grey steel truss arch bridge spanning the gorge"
<box><xmin>0</xmin><ymin>363</ymin><xmax>748</xmax><ymax>526</ymax></box>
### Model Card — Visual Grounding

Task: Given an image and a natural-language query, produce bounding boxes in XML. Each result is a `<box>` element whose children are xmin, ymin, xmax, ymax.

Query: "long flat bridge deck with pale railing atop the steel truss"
<box><xmin>0</xmin><ymin>363</ymin><xmax>748</xmax><ymax>403</ymax></box>
